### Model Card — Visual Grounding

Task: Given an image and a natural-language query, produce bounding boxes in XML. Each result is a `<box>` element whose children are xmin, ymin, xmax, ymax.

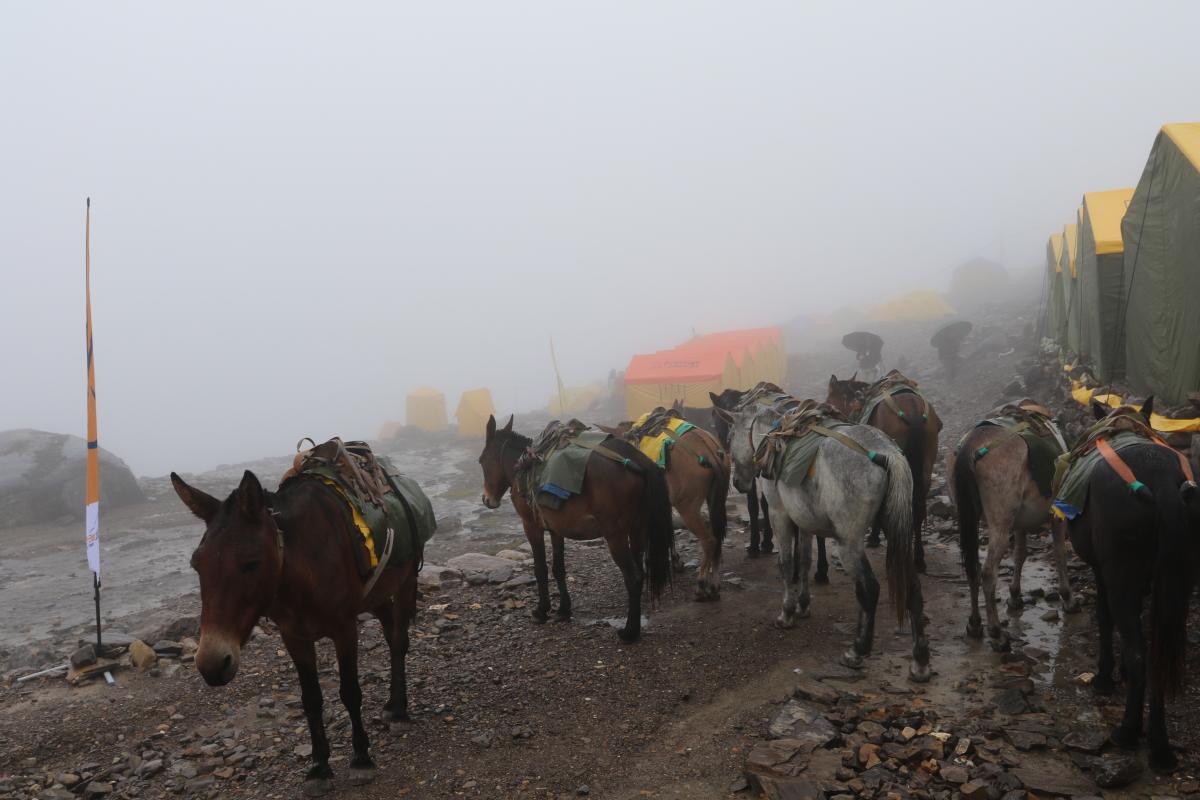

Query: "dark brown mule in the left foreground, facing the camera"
<box><xmin>170</xmin><ymin>470</ymin><xmax>420</xmax><ymax>795</ymax></box>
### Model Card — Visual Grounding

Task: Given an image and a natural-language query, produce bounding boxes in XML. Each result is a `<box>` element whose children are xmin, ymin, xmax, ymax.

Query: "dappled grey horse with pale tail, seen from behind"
<box><xmin>716</xmin><ymin>402</ymin><xmax>931</xmax><ymax>682</ymax></box>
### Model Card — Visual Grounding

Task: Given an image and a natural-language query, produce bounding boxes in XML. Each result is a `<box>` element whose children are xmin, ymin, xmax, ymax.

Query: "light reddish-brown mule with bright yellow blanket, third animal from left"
<box><xmin>596</xmin><ymin>422</ymin><xmax>731</xmax><ymax>601</ymax></box>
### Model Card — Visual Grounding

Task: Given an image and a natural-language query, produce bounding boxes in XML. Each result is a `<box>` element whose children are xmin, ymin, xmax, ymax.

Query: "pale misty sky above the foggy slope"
<box><xmin>0</xmin><ymin>1</ymin><xmax>1200</xmax><ymax>474</ymax></box>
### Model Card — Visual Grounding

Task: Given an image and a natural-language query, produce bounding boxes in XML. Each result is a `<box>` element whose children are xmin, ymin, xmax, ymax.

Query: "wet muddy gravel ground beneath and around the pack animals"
<box><xmin>0</xmin><ymin>303</ymin><xmax>1200</xmax><ymax>800</ymax></box>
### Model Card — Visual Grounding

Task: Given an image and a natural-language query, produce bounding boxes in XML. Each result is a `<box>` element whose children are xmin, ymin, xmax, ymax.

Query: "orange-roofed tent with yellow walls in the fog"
<box><xmin>625</xmin><ymin>327</ymin><xmax>787</xmax><ymax>419</ymax></box>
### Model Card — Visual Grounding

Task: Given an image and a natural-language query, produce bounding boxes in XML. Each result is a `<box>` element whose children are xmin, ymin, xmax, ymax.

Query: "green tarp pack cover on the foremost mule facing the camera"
<box><xmin>304</xmin><ymin>456</ymin><xmax>438</xmax><ymax>566</ymax></box>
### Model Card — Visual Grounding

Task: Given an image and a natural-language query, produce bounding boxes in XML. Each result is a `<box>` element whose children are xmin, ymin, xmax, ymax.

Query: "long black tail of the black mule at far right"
<box><xmin>1150</xmin><ymin>486</ymin><xmax>1192</xmax><ymax>694</ymax></box>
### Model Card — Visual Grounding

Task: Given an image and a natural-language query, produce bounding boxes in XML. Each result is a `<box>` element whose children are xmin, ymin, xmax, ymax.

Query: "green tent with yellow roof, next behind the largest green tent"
<box><xmin>1076</xmin><ymin>188</ymin><xmax>1133</xmax><ymax>380</ymax></box>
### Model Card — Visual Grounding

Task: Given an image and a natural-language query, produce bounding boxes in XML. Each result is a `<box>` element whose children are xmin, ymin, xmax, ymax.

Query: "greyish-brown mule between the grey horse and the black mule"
<box><xmin>946</xmin><ymin>422</ymin><xmax>1079</xmax><ymax>651</ymax></box>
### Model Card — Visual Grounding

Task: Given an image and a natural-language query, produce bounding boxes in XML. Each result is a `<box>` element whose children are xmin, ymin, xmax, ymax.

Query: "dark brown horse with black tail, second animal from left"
<box><xmin>479</xmin><ymin>416</ymin><xmax>674</xmax><ymax>642</ymax></box>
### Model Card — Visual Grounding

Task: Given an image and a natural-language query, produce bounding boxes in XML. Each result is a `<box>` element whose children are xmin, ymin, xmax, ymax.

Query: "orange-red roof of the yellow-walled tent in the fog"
<box><xmin>625</xmin><ymin>327</ymin><xmax>782</xmax><ymax>384</ymax></box>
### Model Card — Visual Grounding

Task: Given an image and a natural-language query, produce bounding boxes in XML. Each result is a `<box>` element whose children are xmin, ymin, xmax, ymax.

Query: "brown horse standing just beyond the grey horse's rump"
<box><xmin>826</xmin><ymin>375</ymin><xmax>942</xmax><ymax>572</ymax></box>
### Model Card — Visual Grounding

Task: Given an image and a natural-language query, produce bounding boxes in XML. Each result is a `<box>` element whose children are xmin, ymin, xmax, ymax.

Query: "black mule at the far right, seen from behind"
<box><xmin>1068</xmin><ymin>398</ymin><xmax>1200</xmax><ymax>770</ymax></box>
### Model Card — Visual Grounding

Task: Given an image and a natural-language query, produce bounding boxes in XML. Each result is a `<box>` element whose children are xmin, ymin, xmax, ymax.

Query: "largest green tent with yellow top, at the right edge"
<box><xmin>1121</xmin><ymin>122</ymin><xmax>1200</xmax><ymax>403</ymax></box>
